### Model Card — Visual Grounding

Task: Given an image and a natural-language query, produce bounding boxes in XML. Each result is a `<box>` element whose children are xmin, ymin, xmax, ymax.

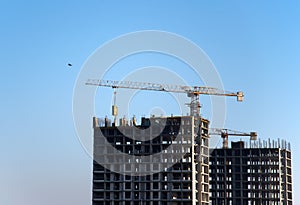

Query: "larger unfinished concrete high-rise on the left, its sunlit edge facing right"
<box><xmin>93</xmin><ymin>116</ymin><xmax>209</xmax><ymax>205</ymax></box>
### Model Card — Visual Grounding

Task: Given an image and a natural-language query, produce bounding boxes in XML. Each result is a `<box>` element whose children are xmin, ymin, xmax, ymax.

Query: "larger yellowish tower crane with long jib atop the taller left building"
<box><xmin>85</xmin><ymin>79</ymin><xmax>244</xmax><ymax>117</ymax></box>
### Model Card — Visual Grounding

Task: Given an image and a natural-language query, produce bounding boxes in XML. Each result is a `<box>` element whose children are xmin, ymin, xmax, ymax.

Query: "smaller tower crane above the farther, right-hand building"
<box><xmin>209</xmin><ymin>128</ymin><xmax>257</xmax><ymax>149</ymax></box>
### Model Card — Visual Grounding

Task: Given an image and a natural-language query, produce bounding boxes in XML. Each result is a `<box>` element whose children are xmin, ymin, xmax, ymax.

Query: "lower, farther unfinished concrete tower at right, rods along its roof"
<box><xmin>210</xmin><ymin>140</ymin><xmax>292</xmax><ymax>205</ymax></box>
